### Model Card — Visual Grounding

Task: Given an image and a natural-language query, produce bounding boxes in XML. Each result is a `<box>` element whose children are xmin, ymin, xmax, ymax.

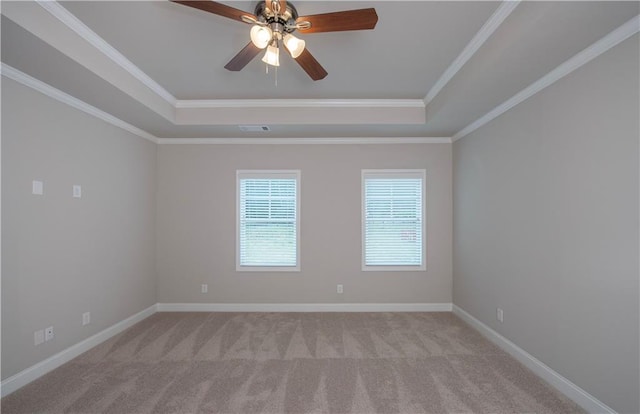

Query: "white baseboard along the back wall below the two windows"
<box><xmin>158</xmin><ymin>303</ymin><xmax>452</xmax><ymax>312</ymax></box>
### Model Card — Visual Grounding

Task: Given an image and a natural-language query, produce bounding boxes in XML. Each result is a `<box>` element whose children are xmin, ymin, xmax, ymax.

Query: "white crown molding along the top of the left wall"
<box><xmin>0</xmin><ymin>63</ymin><xmax>158</xmax><ymax>144</ymax></box>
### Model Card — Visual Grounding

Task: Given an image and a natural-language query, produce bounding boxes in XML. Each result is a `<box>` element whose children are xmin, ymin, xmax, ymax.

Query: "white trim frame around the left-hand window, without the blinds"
<box><xmin>236</xmin><ymin>170</ymin><xmax>301</xmax><ymax>272</ymax></box>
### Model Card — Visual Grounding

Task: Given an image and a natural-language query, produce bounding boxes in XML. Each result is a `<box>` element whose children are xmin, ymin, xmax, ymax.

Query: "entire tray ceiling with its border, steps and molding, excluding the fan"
<box><xmin>2</xmin><ymin>1</ymin><xmax>640</xmax><ymax>138</ymax></box>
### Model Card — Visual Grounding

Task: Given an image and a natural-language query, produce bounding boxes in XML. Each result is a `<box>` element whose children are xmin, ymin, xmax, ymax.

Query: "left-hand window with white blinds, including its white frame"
<box><xmin>236</xmin><ymin>171</ymin><xmax>300</xmax><ymax>271</ymax></box>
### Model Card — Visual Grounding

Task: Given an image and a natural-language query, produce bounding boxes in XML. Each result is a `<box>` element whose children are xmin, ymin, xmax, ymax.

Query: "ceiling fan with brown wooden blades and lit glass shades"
<box><xmin>171</xmin><ymin>0</ymin><xmax>378</xmax><ymax>81</ymax></box>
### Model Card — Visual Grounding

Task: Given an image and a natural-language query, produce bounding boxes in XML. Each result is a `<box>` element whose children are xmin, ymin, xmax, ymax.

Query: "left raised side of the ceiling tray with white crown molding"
<box><xmin>2</xmin><ymin>1</ymin><xmax>175</xmax><ymax>122</ymax></box>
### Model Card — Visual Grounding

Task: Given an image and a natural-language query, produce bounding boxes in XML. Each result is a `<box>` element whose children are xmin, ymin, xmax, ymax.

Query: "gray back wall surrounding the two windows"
<box><xmin>157</xmin><ymin>144</ymin><xmax>452</xmax><ymax>303</ymax></box>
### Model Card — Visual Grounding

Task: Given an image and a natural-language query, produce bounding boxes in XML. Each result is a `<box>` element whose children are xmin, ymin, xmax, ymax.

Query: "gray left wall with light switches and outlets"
<box><xmin>2</xmin><ymin>78</ymin><xmax>156</xmax><ymax>379</ymax></box>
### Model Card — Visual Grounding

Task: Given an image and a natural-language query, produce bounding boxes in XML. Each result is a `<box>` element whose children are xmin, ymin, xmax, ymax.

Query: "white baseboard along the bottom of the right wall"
<box><xmin>453</xmin><ymin>305</ymin><xmax>616</xmax><ymax>414</ymax></box>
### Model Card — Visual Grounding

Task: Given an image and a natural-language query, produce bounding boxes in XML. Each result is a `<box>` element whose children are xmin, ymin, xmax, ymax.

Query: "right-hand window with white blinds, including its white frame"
<box><xmin>362</xmin><ymin>170</ymin><xmax>426</xmax><ymax>270</ymax></box>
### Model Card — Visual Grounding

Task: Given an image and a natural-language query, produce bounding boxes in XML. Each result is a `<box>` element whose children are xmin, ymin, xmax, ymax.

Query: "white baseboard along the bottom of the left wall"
<box><xmin>0</xmin><ymin>304</ymin><xmax>157</xmax><ymax>397</ymax></box>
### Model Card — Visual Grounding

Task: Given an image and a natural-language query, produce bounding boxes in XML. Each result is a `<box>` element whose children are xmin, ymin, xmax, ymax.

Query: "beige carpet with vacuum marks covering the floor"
<box><xmin>2</xmin><ymin>313</ymin><xmax>583</xmax><ymax>414</ymax></box>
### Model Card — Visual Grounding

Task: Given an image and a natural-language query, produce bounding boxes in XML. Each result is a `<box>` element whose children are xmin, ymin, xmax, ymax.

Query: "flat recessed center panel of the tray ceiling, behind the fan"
<box><xmin>62</xmin><ymin>1</ymin><xmax>497</xmax><ymax>99</ymax></box>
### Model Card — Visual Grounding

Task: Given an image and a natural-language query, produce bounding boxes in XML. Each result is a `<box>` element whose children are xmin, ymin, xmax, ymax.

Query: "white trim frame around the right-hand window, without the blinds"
<box><xmin>360</xmin><ymin>169</ymin><xmax>427</xmax><ymax>272</ymax></box>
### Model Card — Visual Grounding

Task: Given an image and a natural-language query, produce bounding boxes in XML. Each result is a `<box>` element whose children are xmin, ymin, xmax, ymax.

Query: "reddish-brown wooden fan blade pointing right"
<box><xmin>296</xmin><ymin>8</ymin><xmax>378</xmax><ymax>33</ymax></box>
